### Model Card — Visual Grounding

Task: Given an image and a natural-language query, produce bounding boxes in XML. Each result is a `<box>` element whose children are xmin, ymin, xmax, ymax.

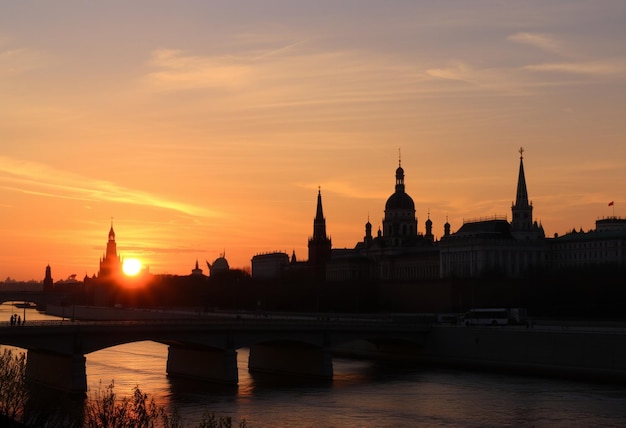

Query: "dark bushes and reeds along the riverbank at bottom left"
<box><xmin>0</xmin><ymin>349</ymin><xmax>247</xmax><ymax>428</ymax></box>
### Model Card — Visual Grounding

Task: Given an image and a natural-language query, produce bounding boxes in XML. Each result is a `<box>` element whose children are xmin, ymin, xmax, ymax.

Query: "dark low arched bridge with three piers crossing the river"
<box><xmin>0</xmin><ymin>317</ymin><xmax>430</xmax><ymax>394</ymax></box>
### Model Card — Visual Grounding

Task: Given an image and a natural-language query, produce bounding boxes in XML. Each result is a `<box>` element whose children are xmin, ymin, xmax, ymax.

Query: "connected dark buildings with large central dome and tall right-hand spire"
<box><xmin>318</xmin><ymin>148</ymin><xmax>626</xmax><ymax>282</ymax></box>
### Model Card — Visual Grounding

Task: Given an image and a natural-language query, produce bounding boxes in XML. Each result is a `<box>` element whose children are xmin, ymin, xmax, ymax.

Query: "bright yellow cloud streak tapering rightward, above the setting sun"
<box><xmin>0</xmin><ymin>156</ymin><xmax>218</xmax><ymax>216</ymax></box>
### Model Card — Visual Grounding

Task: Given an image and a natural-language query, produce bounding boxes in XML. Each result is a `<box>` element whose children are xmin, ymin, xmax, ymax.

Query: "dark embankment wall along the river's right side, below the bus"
<box><xmin>419</xmin><ymin>325</ymin><xmax>626</xmax><ymax>382</ymax></box>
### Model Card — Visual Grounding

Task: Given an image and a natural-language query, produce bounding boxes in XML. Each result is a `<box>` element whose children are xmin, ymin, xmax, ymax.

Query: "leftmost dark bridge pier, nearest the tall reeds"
<box><xmin>26</xmin><ymin>349</ymin><xmax>87</xmax><ymax>394</ymax></box>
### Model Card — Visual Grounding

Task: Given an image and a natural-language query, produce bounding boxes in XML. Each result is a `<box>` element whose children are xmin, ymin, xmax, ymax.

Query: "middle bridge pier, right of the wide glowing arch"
<box><xmin>167</xmin><ymin>346</ymin><xmax>239</xmax><ymax>385</ymax></box>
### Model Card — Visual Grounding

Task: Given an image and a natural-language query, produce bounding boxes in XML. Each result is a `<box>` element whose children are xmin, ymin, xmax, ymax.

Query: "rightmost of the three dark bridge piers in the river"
<box><xmin>248</xmin><ymin>343</ymin><xmax>333</xmax><ymax>379</ymax></box>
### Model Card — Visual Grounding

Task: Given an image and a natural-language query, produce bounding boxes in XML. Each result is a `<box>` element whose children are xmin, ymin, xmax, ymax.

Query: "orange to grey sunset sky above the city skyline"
<box><xmin>0</xmin><ymin>0</ymin><xmax>626</xmax><ymax>280</ymax></box>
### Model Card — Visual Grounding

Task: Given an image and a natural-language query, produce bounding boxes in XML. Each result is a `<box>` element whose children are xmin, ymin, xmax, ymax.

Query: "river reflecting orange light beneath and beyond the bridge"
<box><xmin>0</xmin><ymin>303</ymin><xmax>626</xmax><ymax>428</ymax></box>
